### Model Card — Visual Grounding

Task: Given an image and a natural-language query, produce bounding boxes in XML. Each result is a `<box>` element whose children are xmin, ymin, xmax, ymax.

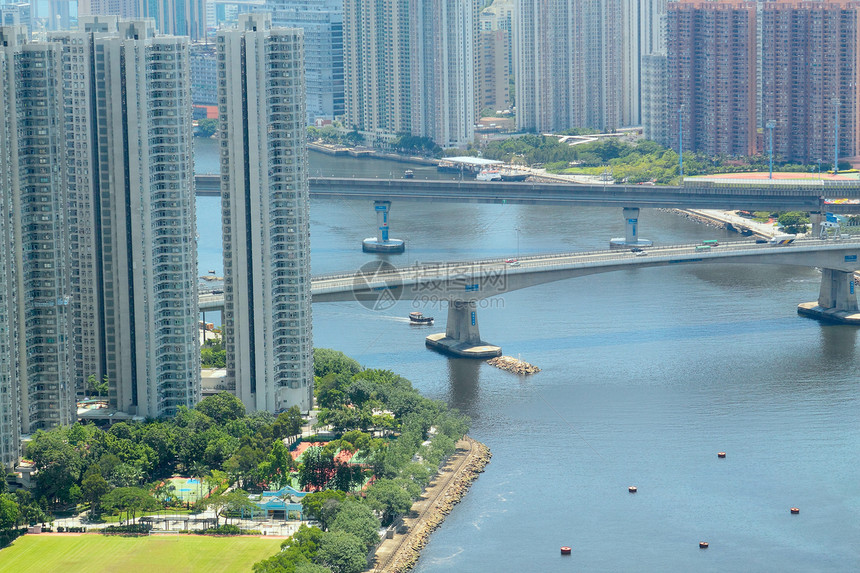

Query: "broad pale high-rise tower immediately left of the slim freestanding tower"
<box><xmin>52</xmin><ymin>17</ymin><xmax>200</xmax><ymax>417</ymax></box>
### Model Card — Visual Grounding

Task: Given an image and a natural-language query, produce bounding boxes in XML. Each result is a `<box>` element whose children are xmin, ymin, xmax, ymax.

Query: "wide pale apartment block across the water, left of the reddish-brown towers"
<box><xmin>514</xmin><ymin>0</ymin><xmax>666</xmax><ymax>132</ymax></box>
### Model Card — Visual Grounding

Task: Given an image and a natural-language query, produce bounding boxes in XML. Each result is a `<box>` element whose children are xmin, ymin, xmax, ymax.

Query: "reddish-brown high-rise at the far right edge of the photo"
<box><xmin>758</xmin><ymin>0</ymin><xmax>860</xmax><ymax>165</ymax></box>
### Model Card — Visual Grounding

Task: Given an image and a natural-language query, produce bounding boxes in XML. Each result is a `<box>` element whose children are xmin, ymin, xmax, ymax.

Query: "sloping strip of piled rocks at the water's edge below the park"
<box><xmin>374</xmin><ymin>436</ymin><xmax>493</xmax><ymax>573</ymax></box>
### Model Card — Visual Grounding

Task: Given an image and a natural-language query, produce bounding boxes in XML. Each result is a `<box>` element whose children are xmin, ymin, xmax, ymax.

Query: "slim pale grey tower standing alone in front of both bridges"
<box><xmin>216</xmin><ymin>14</ymin><xmax>313</xmax><ymax>412</ymax></box>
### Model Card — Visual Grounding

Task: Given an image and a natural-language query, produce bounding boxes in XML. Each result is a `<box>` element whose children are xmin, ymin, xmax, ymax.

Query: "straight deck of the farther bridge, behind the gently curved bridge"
<box><xmin>195</xmin><ymin>174</ymin><xmax>860</xmax><ymax>213</ymax></box>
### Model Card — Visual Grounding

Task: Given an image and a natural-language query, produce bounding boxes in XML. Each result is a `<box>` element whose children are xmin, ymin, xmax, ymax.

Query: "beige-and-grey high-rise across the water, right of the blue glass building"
<box><xmin>343</xmin><ymin>0</ymin><xmax>479</xmax><ymax>147</ymax></box>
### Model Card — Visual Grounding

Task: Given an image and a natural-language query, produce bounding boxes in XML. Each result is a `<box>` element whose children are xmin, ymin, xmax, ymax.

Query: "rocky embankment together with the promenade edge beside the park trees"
<box><xmin>374</xmin><ymin>436</ymin><xmax>493</xmax><ymax>573</ymax></box>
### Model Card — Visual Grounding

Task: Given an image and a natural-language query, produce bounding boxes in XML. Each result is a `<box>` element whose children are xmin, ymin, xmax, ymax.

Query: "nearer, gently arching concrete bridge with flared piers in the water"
<box><xmin>200</xmin><ymin>239</ymin><xmax>860</xmax><ymax>358</ymax></box>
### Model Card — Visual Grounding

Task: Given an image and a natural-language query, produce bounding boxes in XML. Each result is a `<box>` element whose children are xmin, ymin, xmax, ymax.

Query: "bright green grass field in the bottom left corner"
<box><xmin>0</xmin><ymin>534</ymin><xmax>283</xmax><ymax>573</ymax></box>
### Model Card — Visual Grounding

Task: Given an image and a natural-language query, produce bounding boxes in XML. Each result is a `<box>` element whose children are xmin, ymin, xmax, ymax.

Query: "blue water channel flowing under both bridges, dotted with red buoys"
<box><xmin>197</xmin><ymin>140</ymin><xmax>860</xmax><ymax>573</ymax></box>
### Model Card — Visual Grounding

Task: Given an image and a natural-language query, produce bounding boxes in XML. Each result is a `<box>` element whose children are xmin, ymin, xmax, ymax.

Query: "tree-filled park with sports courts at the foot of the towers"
<box><xmin>0</xmin><ymin>349</ymin><xmax>468</xmax><ymax>573</ymax></box>
